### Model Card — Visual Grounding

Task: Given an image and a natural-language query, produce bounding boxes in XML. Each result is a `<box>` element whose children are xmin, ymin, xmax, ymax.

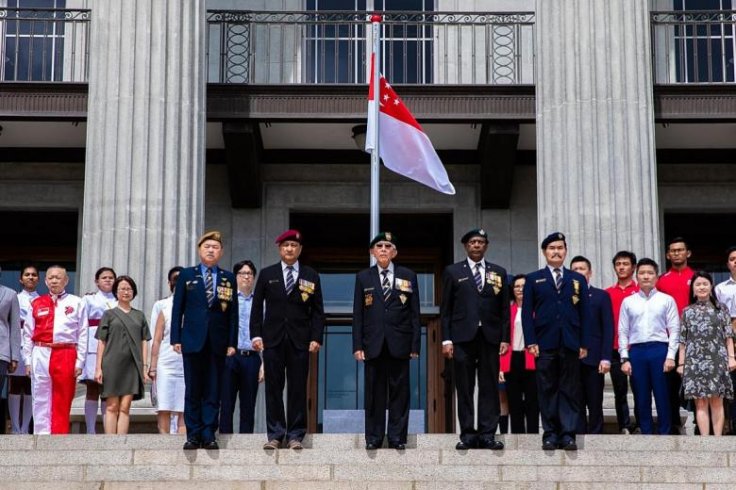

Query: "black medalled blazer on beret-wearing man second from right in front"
<box><xmin>440</xmin><ymin>260</ymin><xmax>510</xmax><ymax>344</ymax></box>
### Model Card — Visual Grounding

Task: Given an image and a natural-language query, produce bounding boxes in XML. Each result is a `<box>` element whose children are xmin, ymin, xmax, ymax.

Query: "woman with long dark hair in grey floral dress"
<box><xmin>677</xmin><ymin>271</ymin><xmax>736</xmax><ymax>436</ymax></box>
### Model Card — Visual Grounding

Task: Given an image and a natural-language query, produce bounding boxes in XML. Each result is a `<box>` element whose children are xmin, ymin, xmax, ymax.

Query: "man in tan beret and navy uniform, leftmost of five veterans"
<box><xmin>171</xmin><ymin>231</ymin><xmax>238</xmax><ymax>449</ymax></box>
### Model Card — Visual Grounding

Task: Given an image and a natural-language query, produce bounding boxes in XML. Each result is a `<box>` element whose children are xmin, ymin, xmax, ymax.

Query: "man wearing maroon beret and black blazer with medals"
<box><xmin>250</xmin><ymin>230</ymin><xmax>325</xmax><ymax>449</ymax></box>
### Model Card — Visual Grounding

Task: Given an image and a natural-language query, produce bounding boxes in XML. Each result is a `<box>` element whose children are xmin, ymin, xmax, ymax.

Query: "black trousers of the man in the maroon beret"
<box><xmin>263</xmin><ymin>337</ymin><xmax>309</xmax><ymax>442</ymax></box>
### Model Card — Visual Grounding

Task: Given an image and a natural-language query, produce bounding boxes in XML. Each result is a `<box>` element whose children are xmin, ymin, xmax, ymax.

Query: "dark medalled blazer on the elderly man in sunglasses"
<box><xmin>353</xmin><ymin>264</ymin><xmax>421</xmax><ymax>360</ymax></box>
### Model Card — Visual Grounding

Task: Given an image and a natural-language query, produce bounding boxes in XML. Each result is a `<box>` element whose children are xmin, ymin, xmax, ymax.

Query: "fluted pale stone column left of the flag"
<box><xmin>79</xmin><ymin>0</ymin><xmax>206</xmax><ymax>314</ymax></box>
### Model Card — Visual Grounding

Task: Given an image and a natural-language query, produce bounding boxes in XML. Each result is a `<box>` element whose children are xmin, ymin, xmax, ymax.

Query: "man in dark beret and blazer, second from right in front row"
<box><xmin>440</xmin><ymin>229</ymin><xmax>510</xmax><ymax>450</ymax></box>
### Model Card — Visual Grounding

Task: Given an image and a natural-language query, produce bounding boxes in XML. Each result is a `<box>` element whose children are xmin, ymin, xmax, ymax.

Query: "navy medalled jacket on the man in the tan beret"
<box><xmin>171</xmin><ymin>264</ymin><xmax>238</xmax><ymax>356</ymax></box>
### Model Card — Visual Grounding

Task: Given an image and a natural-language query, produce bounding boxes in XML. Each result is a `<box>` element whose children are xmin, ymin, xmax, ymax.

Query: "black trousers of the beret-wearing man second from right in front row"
<box><xmin>453</xmin><ymin>329</ymin><xmax>501</xmax><ymax>446</ymax></box>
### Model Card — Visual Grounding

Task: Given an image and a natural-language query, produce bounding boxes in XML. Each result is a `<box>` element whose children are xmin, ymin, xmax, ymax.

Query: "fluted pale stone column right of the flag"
<box><xmin>536</xmin><ymin>0</ymin><xmax>660</xmax><ymax>286</ymax></box>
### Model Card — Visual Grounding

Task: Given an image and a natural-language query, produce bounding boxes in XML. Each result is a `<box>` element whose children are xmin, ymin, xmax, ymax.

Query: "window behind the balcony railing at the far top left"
<box><xmin>0</xmin><ymin>0</ymin><xmax>66</xmax><ymax>81</ymax></box>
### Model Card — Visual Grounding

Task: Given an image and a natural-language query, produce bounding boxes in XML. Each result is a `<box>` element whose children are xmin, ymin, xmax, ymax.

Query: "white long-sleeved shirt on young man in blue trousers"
<box><xmin>618</xmin><ymin>288</ymin><xmax>680</xmax><ymax>360</ymax></box>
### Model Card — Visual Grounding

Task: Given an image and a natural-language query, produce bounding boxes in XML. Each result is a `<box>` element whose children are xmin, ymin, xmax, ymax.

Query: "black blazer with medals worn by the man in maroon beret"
<box><xmin>250</xmin><ymin>262</ymin><xmax>325</xmax><ymax>350</ymax></box>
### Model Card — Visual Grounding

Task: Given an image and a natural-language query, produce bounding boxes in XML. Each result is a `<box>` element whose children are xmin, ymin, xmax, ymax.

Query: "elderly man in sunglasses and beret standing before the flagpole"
<box><xmin>353</xmin><ymin>232</ymin><xmax>421</xmax><ymax>450</ymax></box>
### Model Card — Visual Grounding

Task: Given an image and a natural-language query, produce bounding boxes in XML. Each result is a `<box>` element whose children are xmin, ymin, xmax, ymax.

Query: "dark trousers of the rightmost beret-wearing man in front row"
<box><xmin>537</xmin><ymin>347</ymin><xmax>580</xmax><ymax>443</ymax></box>
